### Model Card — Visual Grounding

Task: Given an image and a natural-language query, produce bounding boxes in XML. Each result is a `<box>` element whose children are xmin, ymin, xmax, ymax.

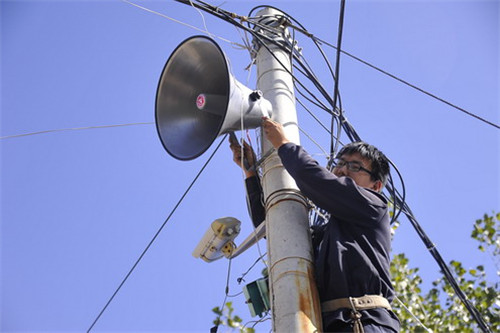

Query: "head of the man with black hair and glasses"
<box><xmin>333</xmin><ymin>142</ymin><xmax>389</xmax><ymax>192</ymax></box>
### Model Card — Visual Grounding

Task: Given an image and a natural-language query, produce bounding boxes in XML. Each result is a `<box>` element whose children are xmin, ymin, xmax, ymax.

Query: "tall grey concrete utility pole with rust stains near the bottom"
<box><xmin>255</xmin><ymin>8</ymin><xmax>321</xmax><ymax>333</ymax></box>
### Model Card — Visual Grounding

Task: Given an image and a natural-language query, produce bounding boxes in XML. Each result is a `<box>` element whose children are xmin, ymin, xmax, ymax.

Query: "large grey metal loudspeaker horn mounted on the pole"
<box><xmin>155</xmin><ymin>36</ymin><xmax>272</xmax><ymax>160</ymax></box>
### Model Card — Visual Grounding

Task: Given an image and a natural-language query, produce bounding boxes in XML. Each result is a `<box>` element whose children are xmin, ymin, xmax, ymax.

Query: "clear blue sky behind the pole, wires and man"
<box><xmin>0</xmin><ymin>0</ymin><xmax>500</xmax><ymax>332</ymax></box>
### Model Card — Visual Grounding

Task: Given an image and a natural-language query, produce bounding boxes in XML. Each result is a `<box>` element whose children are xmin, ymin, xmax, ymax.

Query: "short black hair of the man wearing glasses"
<box><xmin>337</xmin><ymin>141</ymin><xmax>389</xmax><ymax>186</ymax></box>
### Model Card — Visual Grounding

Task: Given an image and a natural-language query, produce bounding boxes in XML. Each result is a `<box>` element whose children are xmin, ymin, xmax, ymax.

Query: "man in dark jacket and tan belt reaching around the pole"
<box><xmin>231</xmin><ymin>118</ymin><xmax>399</xmax><ymax>333</ymax></box>
